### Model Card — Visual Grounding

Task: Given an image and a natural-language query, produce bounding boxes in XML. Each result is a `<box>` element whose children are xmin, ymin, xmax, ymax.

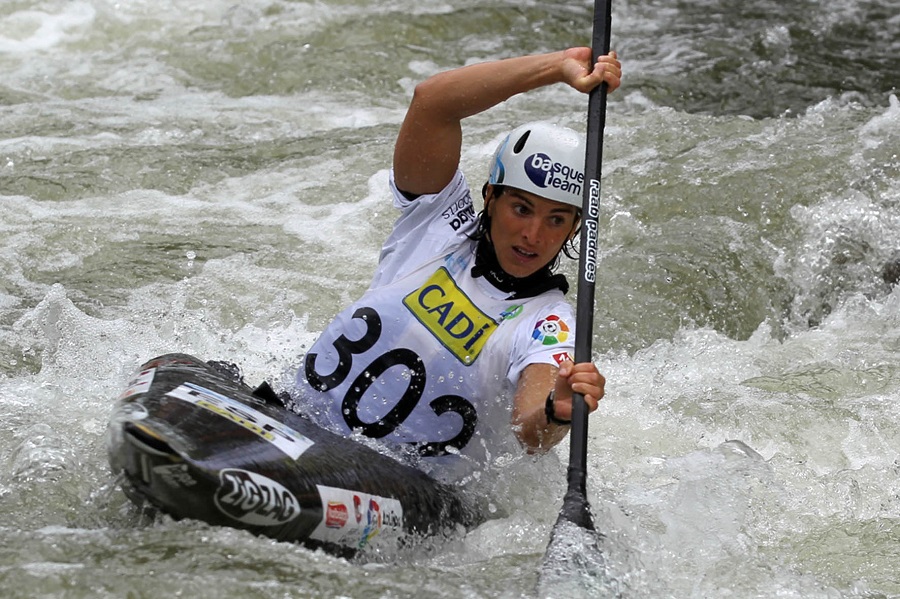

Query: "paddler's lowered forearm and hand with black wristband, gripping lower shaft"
<box><xmin>512</xmin><ymin>362</ymin><xmax>606</xmax><ymax>451</ymax></box>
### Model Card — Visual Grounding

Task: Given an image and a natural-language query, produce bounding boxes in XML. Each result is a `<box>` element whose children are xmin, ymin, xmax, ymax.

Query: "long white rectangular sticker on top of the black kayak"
<box><xmin>166</xmin><ymin>383</ymin><xmax>313</xmax><ymax>460</ymax></box>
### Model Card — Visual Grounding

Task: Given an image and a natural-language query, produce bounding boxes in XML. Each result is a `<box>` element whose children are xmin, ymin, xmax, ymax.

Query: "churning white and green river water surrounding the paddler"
<box><xmin>0</xmin><ymin>0</ymin><xmax>900</xmax><ymax>598</ymax></box>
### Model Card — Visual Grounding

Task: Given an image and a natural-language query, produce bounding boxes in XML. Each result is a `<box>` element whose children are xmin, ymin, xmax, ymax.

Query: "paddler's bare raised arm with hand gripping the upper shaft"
<box><xmin>394</xmin><ymin>48</ymin><xmax>622</xmax><ymax>195</ymax></box>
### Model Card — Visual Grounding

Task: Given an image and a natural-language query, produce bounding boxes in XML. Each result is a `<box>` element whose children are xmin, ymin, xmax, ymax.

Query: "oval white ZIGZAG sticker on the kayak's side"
<box><xmin>215</xmin><ymin>468</ymin><xmax>300</xmax><ymax>526</ymax></box>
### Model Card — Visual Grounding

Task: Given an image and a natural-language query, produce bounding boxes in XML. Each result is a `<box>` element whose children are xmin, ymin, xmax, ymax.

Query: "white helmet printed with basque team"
<box><xmin>488</xmin><ymin>123</ymin><xmax>584</xmax><ymax>208</ymax></box>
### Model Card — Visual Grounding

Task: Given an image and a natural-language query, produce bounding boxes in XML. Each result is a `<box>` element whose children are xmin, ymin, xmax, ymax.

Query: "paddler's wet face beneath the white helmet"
<box><xmin>486</xmin><ymin>186</ymin><xmax>578</xmax><ymax>278</ymax></box>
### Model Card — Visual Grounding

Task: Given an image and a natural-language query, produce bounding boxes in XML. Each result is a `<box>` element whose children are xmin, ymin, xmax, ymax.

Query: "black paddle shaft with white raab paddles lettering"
<box><xmin>563</xmin><ymin>0</ymin><xmax>612</xmax><ymax>529</ymax></box>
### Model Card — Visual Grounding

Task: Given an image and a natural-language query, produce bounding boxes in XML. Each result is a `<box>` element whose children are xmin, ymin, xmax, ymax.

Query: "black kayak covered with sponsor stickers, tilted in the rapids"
<box><xmin>107</xmin><ymin>354</ymin><xmax>483</xmax><ymax>556</ymax></box>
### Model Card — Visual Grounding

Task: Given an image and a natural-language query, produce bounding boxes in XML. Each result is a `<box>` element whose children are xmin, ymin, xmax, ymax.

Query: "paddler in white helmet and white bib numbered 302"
<box><xmin>291</xmin><ymin>48</ymin><xmax>621</xmax><ymax>481</ymax></box>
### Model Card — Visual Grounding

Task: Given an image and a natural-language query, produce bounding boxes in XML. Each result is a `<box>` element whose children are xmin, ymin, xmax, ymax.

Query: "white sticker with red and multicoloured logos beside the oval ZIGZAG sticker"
<box><xmin>310</xmin><ymin>485</ymin><xmax>403</xmax><ymax>549</ymax></box>
